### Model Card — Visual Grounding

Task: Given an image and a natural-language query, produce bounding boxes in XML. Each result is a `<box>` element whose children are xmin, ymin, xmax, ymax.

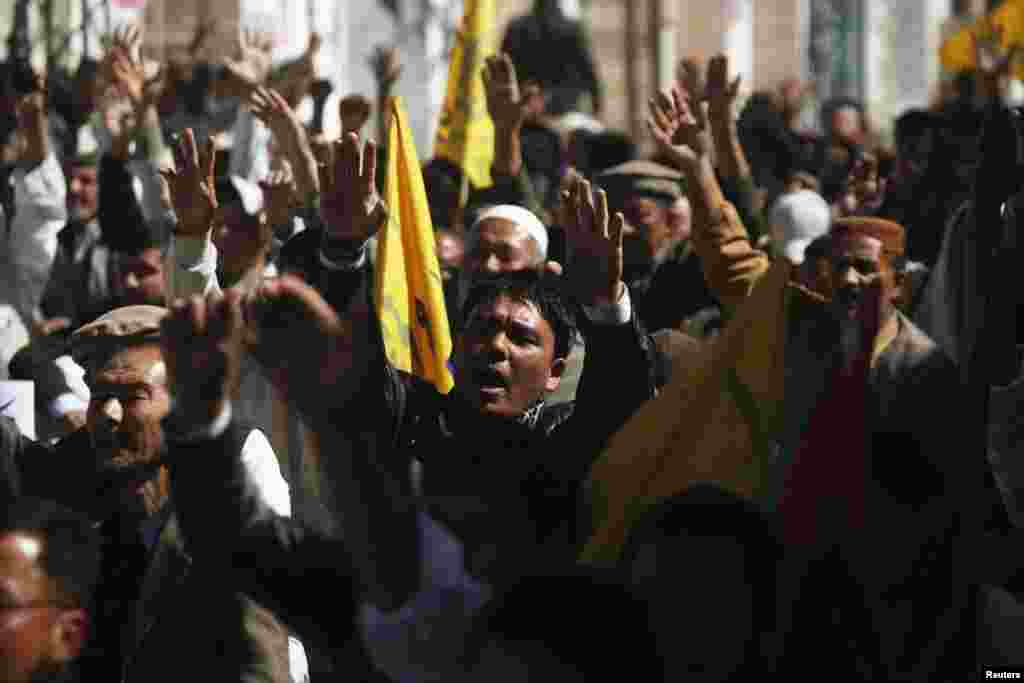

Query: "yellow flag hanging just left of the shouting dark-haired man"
<box><xmin>375</xmin><ymin>97</ymin><xmax>455</xmax><ymax>393</ymax></box>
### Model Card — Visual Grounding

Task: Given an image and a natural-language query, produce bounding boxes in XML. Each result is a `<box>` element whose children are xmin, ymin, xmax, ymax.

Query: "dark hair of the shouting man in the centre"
<box><xmin>462</xmin><ymin>270</ymin><xmax>577</xmax><ymax>358</ymax></box>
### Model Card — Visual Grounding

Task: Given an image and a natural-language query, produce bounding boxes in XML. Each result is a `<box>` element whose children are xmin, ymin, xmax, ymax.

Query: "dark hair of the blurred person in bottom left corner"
<box><xmin>0</xmin><ymin>497</ymin><xmax>100</xmax><ymax>608</ymax></box>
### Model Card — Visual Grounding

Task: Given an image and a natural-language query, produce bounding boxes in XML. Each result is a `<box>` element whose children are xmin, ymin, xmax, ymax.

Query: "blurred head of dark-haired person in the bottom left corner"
<box><xmin>0</xmin><ymin>498</ymin><xmax>100</xmax><ymax>683</ymax></box>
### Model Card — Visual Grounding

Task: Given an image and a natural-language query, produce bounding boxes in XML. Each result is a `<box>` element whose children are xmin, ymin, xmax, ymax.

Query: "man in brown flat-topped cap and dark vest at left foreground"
<box><xmin>2</xmin><ymin>306</ymin><xmax>290</xmax><ymax>681</ymax></box>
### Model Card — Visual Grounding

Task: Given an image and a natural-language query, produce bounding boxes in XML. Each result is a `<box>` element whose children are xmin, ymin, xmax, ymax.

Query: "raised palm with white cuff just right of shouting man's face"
<box><xmin>562</xmin><ymin>178</ymin><xmax>626</xmax><ymax>305</ymax></box>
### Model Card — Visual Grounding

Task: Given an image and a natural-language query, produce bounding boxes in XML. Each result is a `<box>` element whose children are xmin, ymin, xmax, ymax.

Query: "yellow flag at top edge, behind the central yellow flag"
<box><xmin>434</xmin><ymin>0</ymin><xmax>498</xmax><ymax>192</ymax></box>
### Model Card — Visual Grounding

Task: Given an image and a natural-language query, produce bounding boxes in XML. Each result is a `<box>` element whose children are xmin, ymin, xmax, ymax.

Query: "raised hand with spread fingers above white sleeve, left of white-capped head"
<box><xmin>160</xmin><ymin>128</ymin><xmax>217</xmax><ymax>238</ymax></box>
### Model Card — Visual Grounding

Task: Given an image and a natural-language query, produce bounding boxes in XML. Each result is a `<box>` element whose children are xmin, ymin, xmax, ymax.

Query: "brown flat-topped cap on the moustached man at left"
<box><xmin>71</xmin><ymin>306</ymin><xmax>168</xmax><ymax>367</ymax></box>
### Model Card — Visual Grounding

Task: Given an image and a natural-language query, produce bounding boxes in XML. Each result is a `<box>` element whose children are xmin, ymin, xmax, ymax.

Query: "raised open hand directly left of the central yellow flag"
<box><xmin>321</xmin><ymin>133</ymin><xmax>388</xmax><ymax>244</ymax></box>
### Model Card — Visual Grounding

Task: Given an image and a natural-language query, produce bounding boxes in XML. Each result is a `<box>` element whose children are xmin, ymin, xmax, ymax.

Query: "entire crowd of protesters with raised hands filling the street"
<box><xmin>0</xmin><ymin>1</ymin><xmax>1024</xmax><ymax>683</ymax></box>
